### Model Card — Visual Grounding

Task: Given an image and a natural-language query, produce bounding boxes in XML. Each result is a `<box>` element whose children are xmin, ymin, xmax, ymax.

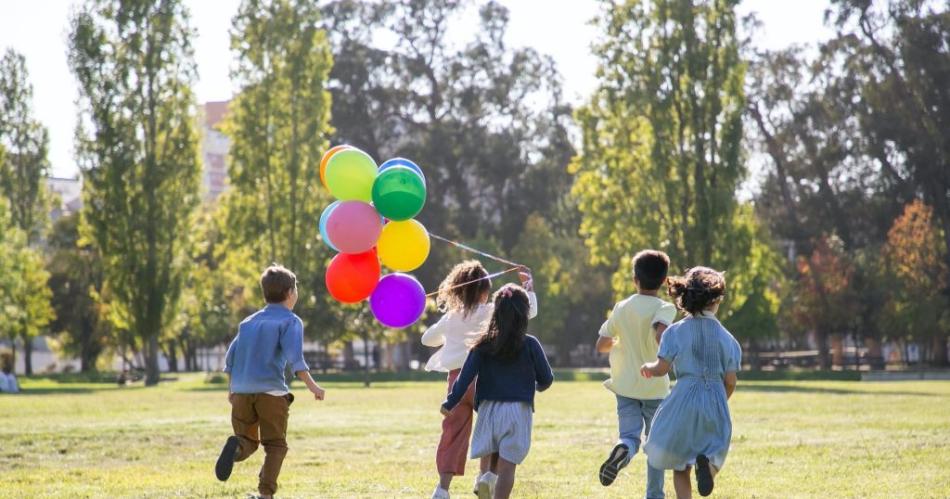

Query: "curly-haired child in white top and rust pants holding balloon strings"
<box><xmin>422</xmin><ymin>260</ymin><xmax>538</xmax><ymax>499</ymax></box>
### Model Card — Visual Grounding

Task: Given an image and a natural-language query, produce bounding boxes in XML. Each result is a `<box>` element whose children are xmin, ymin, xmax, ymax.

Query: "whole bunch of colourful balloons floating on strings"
<box><xmin>320</xmin><ymin>145</ymin><xmax>430</xmax><ymax>328</ymax></box>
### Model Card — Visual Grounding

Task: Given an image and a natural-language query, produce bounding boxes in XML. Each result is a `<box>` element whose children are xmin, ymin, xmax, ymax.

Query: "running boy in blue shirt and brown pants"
<box><xmin>214</xmin><ymin>265</ymin><xmax>324</xmax><ymax>498</ymax></box>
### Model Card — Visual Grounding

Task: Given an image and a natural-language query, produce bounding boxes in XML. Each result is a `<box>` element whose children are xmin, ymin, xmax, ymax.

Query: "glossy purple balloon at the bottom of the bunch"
<box><xmin>369</xmin><ymin>273</ymin><xmax>426</xmax><ymax>328</ymax></box>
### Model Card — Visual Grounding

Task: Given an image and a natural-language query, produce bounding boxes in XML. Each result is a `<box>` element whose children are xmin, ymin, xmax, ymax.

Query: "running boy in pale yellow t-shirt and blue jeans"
<box><xmin>597</xmin><ymin>250</ymin><xmax>676</xmax><ymax>499</ymax></box>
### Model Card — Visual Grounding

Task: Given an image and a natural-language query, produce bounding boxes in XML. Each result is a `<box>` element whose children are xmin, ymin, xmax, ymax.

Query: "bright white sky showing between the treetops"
<box><xmin>0</xmin><ymin>0</ymin><xmax>832</xmax><ymax>177</ymax></box>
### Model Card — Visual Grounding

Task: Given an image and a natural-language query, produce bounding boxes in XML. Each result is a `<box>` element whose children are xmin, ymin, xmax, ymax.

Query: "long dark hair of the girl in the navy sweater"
<box><xmin>474</xmin><ymin>284</ymin><xmax>530</xmax><ymax>361</ymax></box>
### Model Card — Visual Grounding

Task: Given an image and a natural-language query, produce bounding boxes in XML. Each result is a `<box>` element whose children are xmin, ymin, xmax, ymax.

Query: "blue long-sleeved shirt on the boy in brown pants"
<box><xmin>224</xmin><ymin>303</ymin><xmax>310</xmax><ymax>393</ymax></box>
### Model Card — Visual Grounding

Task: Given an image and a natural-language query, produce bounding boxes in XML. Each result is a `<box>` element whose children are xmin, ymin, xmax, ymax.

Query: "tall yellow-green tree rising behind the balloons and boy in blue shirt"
<box><xmin>223</xmin><ymin>0</ymin><xmax>333</xmax><ymax>348</ymax></box>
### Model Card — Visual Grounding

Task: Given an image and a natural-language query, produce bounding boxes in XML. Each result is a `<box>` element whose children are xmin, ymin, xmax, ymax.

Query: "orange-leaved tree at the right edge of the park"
<box><xmin>883</xmin><ymin>200</ymin><xmax>950</xmax><ymax>366</ymax></box>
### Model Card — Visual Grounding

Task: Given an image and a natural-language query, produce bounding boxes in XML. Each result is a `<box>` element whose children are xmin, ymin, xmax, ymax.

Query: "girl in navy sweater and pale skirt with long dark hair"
<box><xmin>442</xmin><ymin>284</ymin><xmax>554</xmax><ymax>499</ymax></box>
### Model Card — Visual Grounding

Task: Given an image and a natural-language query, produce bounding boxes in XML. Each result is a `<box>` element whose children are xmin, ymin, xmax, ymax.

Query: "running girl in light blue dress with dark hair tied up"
<box><xmin>640</xmin><ymin>267</ymin><xmax>742</xmax><ymax>499</ymax></box>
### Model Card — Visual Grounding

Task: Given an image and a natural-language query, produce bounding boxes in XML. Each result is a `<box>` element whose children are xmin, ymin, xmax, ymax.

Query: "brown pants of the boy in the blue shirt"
<box><xmin>231</xmin><ymin>393</ymin><xmax>294</xmax><ymax>495</ymax></box>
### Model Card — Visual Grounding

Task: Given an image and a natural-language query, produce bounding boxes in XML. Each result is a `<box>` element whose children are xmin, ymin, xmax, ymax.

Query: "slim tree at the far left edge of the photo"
<box><xmin>0</xmin><ymin>49</ymin><xmax>51</xmax><ymax>375</ymax></box>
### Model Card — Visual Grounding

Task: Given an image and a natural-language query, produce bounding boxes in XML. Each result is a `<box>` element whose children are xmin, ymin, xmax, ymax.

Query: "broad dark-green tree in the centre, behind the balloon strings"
<box><xmin>324</xmin><ymin>0</ymin><xmax>606</xmax><ymax>362</ymax></box>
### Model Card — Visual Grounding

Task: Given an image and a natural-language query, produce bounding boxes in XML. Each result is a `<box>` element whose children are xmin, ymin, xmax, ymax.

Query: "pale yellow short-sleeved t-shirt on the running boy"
<box><xmin>599</xmin><ymin>294</ymin><xmax>676</xmax><ymax>400</ymax></box>
